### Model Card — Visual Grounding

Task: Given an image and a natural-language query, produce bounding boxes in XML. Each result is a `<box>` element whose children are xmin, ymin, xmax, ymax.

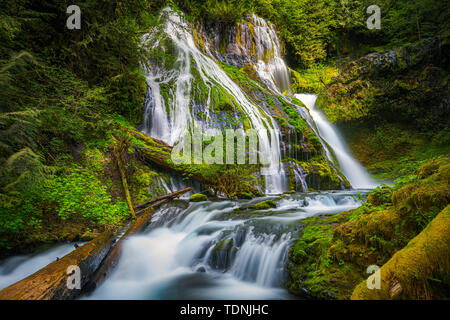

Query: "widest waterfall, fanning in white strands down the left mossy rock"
<box><xmin>143</xmin><ymin>8</ymin><xmax>286</xmax><ymax>194</ymax></box>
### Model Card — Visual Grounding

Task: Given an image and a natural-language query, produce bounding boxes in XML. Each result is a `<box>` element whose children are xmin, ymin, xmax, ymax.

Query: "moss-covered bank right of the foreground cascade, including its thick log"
<box><xmin>287</xmin><ymin>158</ymin><xmax>450</xmax><ymax>299</ymax></box>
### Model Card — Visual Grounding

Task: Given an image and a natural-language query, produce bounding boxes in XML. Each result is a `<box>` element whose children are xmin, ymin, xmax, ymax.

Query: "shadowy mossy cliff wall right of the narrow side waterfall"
<box><xmin>318</xmin><ymin>36</ymin><xmax>450</xmax><ymax>128</ymax></box>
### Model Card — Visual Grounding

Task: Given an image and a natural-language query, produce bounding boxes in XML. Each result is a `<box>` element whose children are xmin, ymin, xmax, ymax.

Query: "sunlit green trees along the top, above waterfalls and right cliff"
<box><xmin>171</xmin><ymin>0</ymin><xmax>450</xmax><ymax>68</ymax></box>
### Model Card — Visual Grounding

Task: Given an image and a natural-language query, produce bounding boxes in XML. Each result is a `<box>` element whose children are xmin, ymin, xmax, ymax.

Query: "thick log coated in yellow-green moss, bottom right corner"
<box><xmin>351</xmin><ymin>206</ymin><xmax>450</xmax><ymax>300</ymax></box>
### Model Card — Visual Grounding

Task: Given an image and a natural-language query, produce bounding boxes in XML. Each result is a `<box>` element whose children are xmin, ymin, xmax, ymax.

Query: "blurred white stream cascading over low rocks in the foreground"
<box><xmin>85</xmin><ymin>191</ymin><xmax>360</xmax><ymax>299</ymax></box>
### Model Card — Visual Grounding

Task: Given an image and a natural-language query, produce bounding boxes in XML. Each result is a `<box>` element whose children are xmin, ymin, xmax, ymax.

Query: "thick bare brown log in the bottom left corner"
<box><xmin>0</xmin><ymin>230</ymin><xmax>115</xmax><ymax>300</ymax></box>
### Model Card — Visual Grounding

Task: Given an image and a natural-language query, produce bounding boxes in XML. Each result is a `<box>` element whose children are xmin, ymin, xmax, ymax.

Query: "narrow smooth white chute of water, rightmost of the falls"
<box><xmin>294</xmin><ymin>94</ymin><xmax>378</xmax><ymax>189</ymax></box>
